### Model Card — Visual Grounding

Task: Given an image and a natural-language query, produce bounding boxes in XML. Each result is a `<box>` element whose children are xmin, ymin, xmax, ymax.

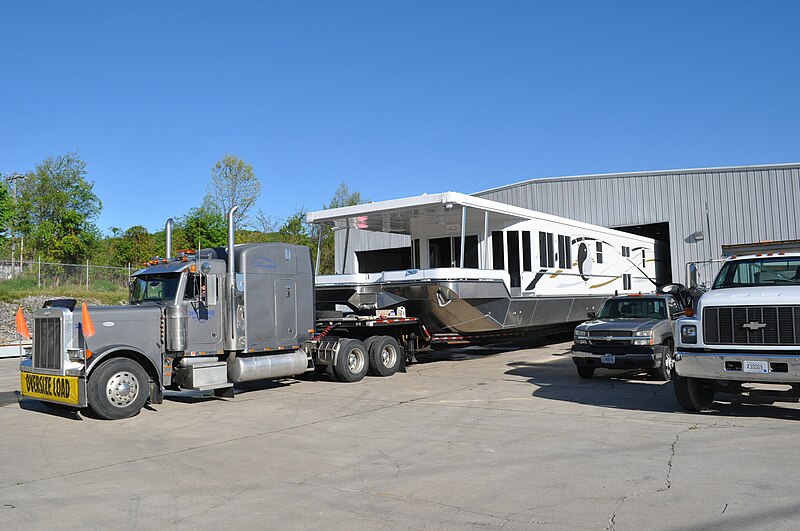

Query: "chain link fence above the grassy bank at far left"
<box><xmin>0</xmin><ymin>260</ymin><xmax>132</xmax><ymax>291</ymax></box>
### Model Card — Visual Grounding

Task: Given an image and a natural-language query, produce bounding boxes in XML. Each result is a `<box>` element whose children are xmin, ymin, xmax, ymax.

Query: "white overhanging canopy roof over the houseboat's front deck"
<box><xmin>306</xmin><ymin>192</ymin><xmax>536</xmax><ymax>234</ymax></box>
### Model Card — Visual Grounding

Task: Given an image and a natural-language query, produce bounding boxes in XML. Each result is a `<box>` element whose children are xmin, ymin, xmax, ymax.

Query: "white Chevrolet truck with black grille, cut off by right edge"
<box><xmin>673</xmin><ymin>252</ymin><xmax>800</xmax><ymax>411</ymax></box>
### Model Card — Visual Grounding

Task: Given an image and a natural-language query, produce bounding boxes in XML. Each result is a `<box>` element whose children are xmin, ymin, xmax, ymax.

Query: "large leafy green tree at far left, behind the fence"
<box><xmin>17</xmin><ymin>153</ymin><xmax>102</xmax><ymax>263</ymax></box>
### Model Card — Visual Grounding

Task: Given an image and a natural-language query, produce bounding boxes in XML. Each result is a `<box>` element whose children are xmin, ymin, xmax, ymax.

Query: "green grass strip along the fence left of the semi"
<box><xmin>0</xmin><ymin>276</ymin><xmax>128</xmax><ymax>304</ymax></box>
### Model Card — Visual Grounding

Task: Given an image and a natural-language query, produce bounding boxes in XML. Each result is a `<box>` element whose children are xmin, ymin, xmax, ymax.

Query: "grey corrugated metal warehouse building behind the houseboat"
<box><xmin>336</xmin><ymin>163</ymin><xmax>800</xmax><ymax>282</ymax></box>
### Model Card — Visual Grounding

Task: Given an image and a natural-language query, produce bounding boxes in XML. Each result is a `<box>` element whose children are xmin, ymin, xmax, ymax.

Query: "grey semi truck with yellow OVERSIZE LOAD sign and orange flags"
<box><xmin>17</xmin><ymin>206</ymin><xmax>432</xmax><ymax>420</ymax></box>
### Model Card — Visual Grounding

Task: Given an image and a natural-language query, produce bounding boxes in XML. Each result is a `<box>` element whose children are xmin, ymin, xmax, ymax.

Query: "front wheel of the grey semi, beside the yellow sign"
<box><xmin>87</xmin><ymin>358</ymin><xmax>149</xmax><ymax>420</ymax></box>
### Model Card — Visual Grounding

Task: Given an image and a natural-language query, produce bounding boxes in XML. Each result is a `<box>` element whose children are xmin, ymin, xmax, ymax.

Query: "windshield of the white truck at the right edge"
<box><xmin>711</xmin><ymin>257</ymin><xmax>800</xmax><ymax>289</ymax></box>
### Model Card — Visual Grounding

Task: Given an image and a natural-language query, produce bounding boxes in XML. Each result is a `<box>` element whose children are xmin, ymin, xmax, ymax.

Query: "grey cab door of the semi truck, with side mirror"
<box><xmin>184</xmin><ymin>274</ymin><xmax>222</xmax><ymax>352</ymax></box>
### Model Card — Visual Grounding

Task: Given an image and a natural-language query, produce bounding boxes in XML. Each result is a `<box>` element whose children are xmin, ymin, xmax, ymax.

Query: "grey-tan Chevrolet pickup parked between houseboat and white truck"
<box><xmin>572</xmin><ymin>290</ymin><xmax>684</xmax><ymax>381</ymax></box>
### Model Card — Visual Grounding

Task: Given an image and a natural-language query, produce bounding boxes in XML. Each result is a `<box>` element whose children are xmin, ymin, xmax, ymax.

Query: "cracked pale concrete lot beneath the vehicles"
<box><xmin>0</xmin><ymin>343</ymin><xmax>800</xmax><ymax>530</ymax></box>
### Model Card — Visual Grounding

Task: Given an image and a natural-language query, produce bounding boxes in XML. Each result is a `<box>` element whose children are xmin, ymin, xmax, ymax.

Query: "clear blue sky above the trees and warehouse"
<box><xmin>0</xmin><ymin>0</ymin><xmax>800</xmax><ymax>231</ymax></box>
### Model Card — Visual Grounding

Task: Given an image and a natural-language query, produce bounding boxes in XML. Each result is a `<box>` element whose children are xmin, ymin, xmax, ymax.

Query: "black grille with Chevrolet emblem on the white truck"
<box><xmin>703</xmin><ymin>306</ymin><xmax>800</xmax><ymax>345</ymax></box>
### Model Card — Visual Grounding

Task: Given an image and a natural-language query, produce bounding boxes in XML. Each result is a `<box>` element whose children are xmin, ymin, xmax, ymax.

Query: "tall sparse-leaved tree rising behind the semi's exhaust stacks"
<box><xmin>203</xmin><ymin>155</ymin><xmax>261</xmax><ymax>228</ymax></box>
